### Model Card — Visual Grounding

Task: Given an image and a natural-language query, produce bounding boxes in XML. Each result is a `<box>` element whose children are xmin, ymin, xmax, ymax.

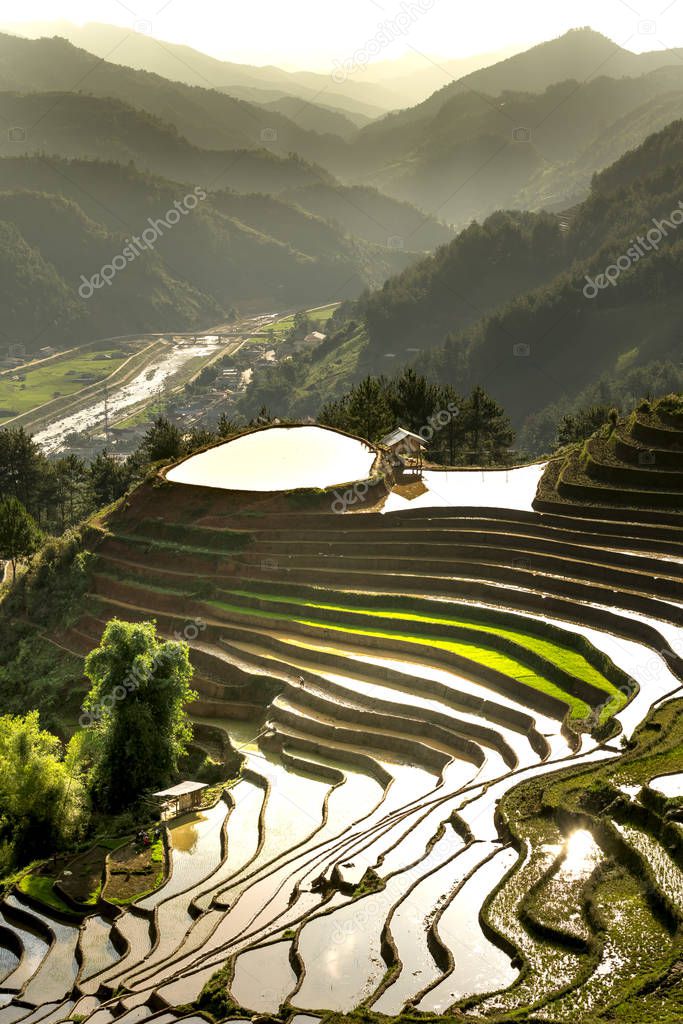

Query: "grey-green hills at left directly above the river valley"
<box><xmin>0</xmin><ymin>158</ymin><xmax>410</xmax><ymax>350</ymax></box>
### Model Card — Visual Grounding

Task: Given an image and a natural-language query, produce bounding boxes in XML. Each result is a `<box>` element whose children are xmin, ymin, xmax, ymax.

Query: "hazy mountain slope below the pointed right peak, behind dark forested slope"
<box><xmin>355</xmin><ymin>65</ymin><xmax>683</xmax><ymax>225</ymax></box>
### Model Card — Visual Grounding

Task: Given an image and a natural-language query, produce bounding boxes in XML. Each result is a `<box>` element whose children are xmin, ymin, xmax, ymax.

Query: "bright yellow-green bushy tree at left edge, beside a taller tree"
<box><xmin>0</xmin><ymin>711</ymin><xmax>84</xmax><ymax>868</ymax></box>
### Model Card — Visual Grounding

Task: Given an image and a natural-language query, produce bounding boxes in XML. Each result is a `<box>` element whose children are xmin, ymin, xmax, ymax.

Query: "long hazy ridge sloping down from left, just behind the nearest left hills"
<box><xmin>0</xmin><ymin>93</ymin><xmax>453</xmax><ymax>252</ymax></box>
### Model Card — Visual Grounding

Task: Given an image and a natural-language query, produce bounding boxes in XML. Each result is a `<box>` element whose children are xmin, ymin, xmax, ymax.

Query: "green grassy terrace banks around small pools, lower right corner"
<box><xmin>481</xmin><ymin>700</ymin><xmax>683</xmax><ymax>1024</ymax></box>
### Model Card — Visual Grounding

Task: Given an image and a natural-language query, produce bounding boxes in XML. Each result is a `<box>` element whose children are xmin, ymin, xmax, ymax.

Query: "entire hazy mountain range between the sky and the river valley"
<box><xmin>0</xmin><ymin>18</ymin><xmax>683</xmax><ymax>415</ymax></box>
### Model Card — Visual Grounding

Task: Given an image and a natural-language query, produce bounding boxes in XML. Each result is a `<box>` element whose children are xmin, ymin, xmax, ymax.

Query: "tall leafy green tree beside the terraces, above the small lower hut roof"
<box><xmin>84</xmin><ymin>618</ymin><xmax>197</xmax><ymax>812</ymax></box>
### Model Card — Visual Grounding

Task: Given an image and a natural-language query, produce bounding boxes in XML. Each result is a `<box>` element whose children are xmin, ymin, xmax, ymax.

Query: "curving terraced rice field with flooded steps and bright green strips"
<box><xmin>0</xmin><ymin>456</ymin><xmax>683</xmax><ymax>1024</ymax></box>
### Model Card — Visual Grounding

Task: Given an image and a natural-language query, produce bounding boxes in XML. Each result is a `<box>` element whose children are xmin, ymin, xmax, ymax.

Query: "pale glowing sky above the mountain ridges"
<box><xmin>0</xmin><ymin>0</ymin><xmax>683</xmax><ymax>71</ymax></box>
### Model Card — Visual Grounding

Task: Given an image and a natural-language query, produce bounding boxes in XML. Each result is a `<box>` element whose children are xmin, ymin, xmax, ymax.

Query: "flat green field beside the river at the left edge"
<box><xmin>0</xmin><ymin>345</ymin><xmax>137</xmax><ymax>423</ymax></box>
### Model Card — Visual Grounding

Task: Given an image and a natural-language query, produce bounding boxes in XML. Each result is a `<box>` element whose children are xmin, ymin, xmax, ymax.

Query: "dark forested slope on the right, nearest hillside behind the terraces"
<box><xmin>242</xmin><ymin>121</ymin><xmax>683</xmax><ymax>436</ymax></box>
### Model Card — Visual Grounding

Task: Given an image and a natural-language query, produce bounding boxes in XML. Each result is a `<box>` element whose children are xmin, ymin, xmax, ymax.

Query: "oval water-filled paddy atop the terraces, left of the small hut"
<box><xmin>167</xmin><ymin>427</ymin><xmax>376</xmax><ymax>492</ymax></box>
